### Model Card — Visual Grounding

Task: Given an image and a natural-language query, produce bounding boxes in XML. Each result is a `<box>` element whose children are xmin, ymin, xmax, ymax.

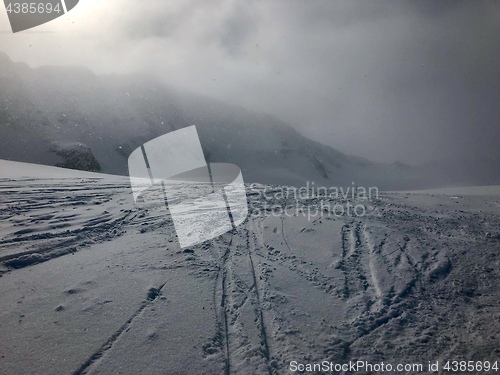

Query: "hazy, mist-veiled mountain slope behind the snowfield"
<box><xmin>0</xmin><ymin>53</ymin><xmax>500</xmax><ymax>189</ymax></box>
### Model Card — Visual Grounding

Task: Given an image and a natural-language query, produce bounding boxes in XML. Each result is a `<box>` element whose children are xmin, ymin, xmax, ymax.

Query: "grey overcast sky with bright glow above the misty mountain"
<box><xmin>0</xmin><ymin>0</ymin><xmax>500</xmax><ymax>163</ymax></box>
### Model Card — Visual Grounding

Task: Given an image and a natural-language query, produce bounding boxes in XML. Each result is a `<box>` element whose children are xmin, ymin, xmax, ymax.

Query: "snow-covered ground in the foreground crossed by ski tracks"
<box><xmin>0</xmin><ymin>161</ymin><xmax>500</xmax><ymax>375</ymax></box>
